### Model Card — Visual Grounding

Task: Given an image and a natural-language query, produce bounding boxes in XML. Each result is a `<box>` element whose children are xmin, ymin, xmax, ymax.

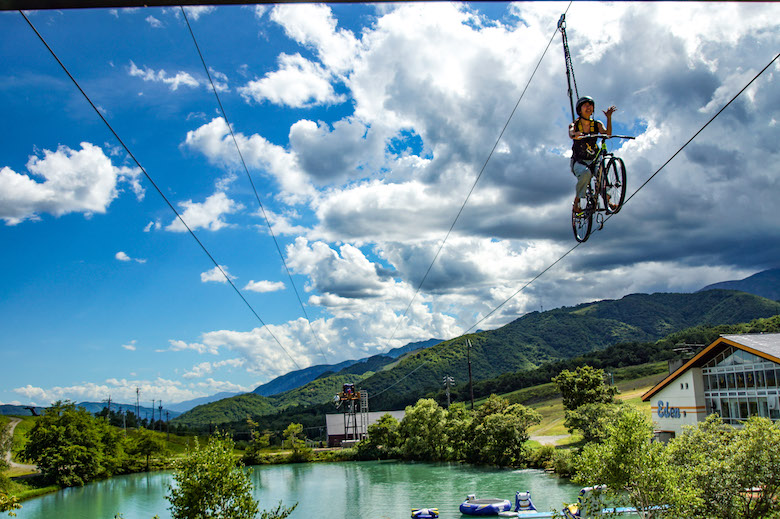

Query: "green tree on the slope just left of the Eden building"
<box><xmin>552</xmin><ymin>366</ymin><xmax>618</xmax><ymax>438</ymax></box>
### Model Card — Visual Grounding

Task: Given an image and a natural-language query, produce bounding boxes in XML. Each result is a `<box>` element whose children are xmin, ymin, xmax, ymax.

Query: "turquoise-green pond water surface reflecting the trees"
<box><xmin>17</xmin><ymin>461</ymin><xmax>579</xmax><ymax>519</ymax></box>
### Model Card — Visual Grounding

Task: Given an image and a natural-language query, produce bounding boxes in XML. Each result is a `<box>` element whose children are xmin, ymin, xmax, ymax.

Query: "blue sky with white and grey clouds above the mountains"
<box><xmin>0</xmin><ymin>2</ymin><xmax>780</xmax><ymax>405</ymax></box>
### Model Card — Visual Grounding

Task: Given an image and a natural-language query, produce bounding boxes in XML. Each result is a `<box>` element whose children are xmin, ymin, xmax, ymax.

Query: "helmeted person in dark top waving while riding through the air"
<box><xmin>569</xmin><ymin>96</ymin><xmax>617</xmax><ymax>212</ymax></box>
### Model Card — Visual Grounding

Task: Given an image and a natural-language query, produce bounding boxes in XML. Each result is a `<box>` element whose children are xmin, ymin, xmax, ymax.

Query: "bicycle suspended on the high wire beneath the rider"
<box><xmin>571</xmin><ymin>133</ymin><xmax>634</xmax><ymax>243</ymax></box>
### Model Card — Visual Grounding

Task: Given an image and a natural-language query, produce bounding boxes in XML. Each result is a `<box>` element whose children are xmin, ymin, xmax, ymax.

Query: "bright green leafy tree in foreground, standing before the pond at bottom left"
<box><xmin>166</xmin><ymin>433</ymin><xmax>295</xmax><ymax>519</ymax></box>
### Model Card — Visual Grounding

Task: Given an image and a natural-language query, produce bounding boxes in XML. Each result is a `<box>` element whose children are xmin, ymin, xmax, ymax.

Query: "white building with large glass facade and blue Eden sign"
<box><xmin>642</xmin><ymin>333</ymin><xmax>780</xmax><ymax>439</ymax></box>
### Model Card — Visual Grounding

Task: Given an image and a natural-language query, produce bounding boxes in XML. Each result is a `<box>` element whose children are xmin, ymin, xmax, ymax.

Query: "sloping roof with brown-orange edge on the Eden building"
<box><xmin>642</xmin><ymin>333</ymin><xmax>780</xmax><ymax>402</ymax></box>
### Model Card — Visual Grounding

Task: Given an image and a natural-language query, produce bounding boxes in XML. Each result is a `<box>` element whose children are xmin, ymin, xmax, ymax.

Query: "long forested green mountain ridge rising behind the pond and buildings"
<box><xmin>176</xmin><ymin>290</ymin><xmax>780</xmax><ymax>425</ymax></box>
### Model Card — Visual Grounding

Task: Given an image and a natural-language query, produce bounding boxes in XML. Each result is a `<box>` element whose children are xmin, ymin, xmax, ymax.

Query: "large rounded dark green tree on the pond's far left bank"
<box><xmin>21</xmin><ymin>401</ymin><xmax>126</xmax><ymax>486</ymax></box>
